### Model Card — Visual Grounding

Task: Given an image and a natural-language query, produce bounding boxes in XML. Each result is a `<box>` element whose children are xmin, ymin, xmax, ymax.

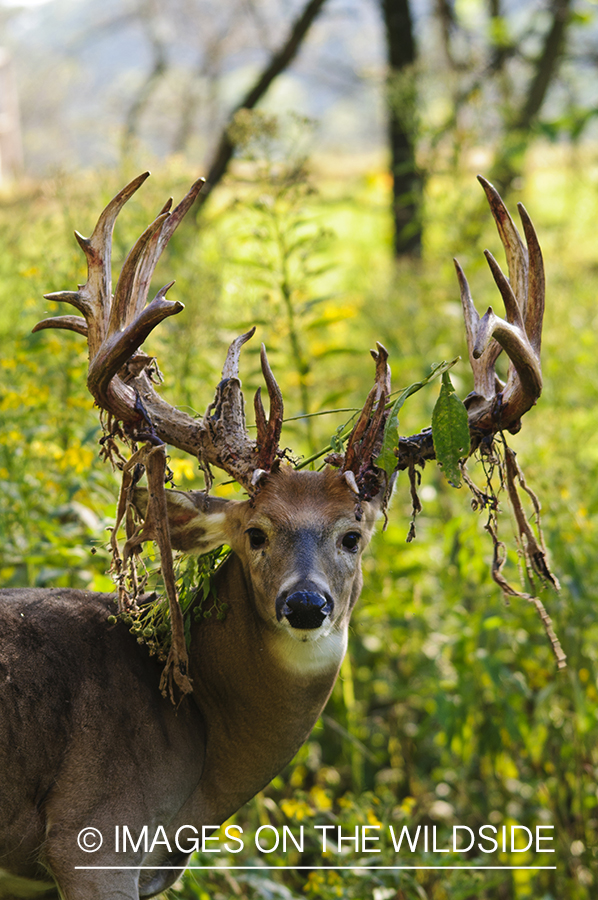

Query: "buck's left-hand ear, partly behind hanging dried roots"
<box><xmin>133</xmin><ymin>487</ymin><xmax>234</xmax><ymax>555</ymax></box>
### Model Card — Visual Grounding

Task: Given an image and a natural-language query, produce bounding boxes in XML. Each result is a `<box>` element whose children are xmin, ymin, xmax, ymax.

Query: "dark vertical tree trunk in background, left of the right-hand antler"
<box><xmin>381</xmin><ymin>0</ymin><xmax>423</xmax><ymax>257</ymax></box>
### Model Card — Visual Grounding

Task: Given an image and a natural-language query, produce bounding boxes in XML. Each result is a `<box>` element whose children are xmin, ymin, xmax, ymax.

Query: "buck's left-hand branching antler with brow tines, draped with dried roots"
<box><xmin>33</xmin><ymin>172</ymin><xmax>283</xmax><ymax>493</ymax></box>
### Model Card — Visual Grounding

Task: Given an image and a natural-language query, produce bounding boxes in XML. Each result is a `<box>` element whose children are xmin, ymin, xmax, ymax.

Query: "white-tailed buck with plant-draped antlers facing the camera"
<box><xmin>0</xmin><ymin>175</ymin><xmax>544</xmax><ymax>900</ymax></box>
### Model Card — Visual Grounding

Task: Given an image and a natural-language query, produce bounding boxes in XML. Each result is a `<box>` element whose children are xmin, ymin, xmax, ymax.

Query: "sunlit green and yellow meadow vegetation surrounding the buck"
<box><xmin>0</xmin><ymin>149</ymin><xmax>598</xmax><ymax>900</ymax></box>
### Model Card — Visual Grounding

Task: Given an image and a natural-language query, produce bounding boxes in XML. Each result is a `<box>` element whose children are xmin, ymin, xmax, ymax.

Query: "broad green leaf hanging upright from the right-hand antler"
<box><xmin>432</xmin><ymin>372</ymin><xmax>469</xmax><ymax>487</ymax></box>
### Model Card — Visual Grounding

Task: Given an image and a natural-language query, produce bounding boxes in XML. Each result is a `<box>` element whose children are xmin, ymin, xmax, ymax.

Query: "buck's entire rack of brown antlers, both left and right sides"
<box><xmin>34</xmin><ymin>173</ymin><xmax>544</xmax><ymax>499</ymax></box>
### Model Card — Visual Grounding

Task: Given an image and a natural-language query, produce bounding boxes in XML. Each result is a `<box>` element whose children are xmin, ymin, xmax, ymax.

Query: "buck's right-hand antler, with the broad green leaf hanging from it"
<box><xmin>310</xmin><ymin>176</ymin><xmax>544</xmax><ymax>500</ymax></box>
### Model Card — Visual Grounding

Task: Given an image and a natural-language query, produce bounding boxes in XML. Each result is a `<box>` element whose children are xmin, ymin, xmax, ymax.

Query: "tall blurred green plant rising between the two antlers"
<box><xmin>230</xmin><ymin>110</ymin><xmax>334</xmax><ymax>453</ymax></box>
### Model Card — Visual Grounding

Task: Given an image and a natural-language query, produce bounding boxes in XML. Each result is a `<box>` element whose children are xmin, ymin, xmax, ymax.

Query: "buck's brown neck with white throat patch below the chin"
<box><xmin>190</xmin><ymin>555</ymin><xmax>346</xmax><ymax>824</ymax></box>
